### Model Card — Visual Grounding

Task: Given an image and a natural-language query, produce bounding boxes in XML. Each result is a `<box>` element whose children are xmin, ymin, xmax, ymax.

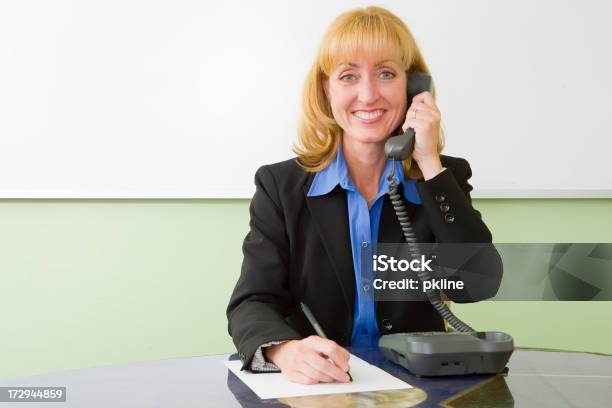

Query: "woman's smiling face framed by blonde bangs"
<box><xmin>324</xmin><ymin>53</ymin><xmax>407</xmax><ymax>143</ymax></box>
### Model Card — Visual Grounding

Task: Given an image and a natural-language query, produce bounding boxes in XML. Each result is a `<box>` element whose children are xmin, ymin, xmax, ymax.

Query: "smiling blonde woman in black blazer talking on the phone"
<box><xmin>227</xmin><ymin>7</ymin><xmax>501</xmax><ymax>384</ymax></box>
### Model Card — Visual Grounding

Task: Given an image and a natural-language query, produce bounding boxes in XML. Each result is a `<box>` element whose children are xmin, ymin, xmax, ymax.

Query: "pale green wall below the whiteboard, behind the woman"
<box><xmin>0</xmin><ymin>200</ymin><xmax>612</xmax><ymax>378</ymax></box>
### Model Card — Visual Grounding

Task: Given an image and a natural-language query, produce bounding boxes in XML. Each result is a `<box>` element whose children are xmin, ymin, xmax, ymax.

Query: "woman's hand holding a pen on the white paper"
<box><xmin>263</xmin><ymin>336</ymin><xmax>350</xmax><ymax>384</ymax></box>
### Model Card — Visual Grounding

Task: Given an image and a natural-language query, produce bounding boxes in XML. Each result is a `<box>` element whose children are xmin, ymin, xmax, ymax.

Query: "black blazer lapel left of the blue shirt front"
<box><xmin>304</xmin><ymin>185</ymin><xmax>355</xmax><ymax>317</ymax></box>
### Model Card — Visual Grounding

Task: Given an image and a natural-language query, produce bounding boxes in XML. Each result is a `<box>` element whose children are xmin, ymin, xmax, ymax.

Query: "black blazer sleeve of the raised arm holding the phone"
<box><xmin>417</xmin><ymin>158</ymin><xmax>503</xmax><ymax>303</ymax></box>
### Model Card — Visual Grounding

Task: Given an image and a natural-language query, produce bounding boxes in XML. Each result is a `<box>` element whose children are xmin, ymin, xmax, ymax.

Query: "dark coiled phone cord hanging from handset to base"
<box><xmin>387</xmin><ymin>160</ymin><xmax>475</xmax><ymax>332</ymax></box>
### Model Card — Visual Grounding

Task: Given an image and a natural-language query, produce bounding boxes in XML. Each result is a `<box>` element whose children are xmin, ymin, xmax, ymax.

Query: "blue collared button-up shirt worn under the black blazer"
<box><xmin>308</xmin><ymin>146</ymin><xmax>421</xmax><ymax>347</ymax></box>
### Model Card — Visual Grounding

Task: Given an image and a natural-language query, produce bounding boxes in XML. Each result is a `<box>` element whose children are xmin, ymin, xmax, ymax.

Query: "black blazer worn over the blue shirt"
<box><xmin>227</xmin><ymin>156</ymin><xmax>502</xmax><ymax>369</ymax></box>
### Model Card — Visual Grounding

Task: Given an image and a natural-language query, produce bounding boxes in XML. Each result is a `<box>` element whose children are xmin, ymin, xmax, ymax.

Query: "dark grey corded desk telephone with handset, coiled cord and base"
<box><xmin>378</xmin><ymin>71</ymin><xmax>514</xmax><ymax>376</ymax></box>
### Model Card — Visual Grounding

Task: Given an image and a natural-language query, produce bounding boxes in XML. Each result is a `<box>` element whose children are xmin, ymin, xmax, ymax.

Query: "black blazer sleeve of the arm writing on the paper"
<box><xmin>227</xmin><ymin>166</ymin><xmax>302</xmax><ymax>370</ymax></box>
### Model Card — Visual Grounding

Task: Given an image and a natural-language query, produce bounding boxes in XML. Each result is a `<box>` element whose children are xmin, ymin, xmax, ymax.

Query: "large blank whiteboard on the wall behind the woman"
<box><xmin>0</xmin><ymin>0</ymin><xmax>612</xmax><ymax>198</ymax></box>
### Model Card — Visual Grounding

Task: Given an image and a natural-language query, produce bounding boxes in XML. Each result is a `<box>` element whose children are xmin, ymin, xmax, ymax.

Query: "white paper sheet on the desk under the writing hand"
<box><xmin>225</xmin><ymin>354</ymin><xmax>412</xmax><ymax>399</ymax></box>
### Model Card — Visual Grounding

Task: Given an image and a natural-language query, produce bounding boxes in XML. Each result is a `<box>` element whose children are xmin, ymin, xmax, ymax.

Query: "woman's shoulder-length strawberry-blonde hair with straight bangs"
<box><xmin>293</xmin><ymin>7</ymin><xmax>444</xmax><ymax>179</ymax></box>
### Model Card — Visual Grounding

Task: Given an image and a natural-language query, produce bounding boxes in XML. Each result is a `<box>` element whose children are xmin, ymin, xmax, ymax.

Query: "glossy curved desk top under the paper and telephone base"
<box><xmin>0</xmin><ymin>349</ymin><xmax>612</xmax><ymax>408</ymax></box>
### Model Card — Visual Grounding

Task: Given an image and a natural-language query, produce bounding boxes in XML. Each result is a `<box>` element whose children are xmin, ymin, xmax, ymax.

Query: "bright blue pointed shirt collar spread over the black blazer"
<box><xmin>307</xmin><ymin>145</ymin><xmax>421</xmax><ymax>204</ymax></box>
